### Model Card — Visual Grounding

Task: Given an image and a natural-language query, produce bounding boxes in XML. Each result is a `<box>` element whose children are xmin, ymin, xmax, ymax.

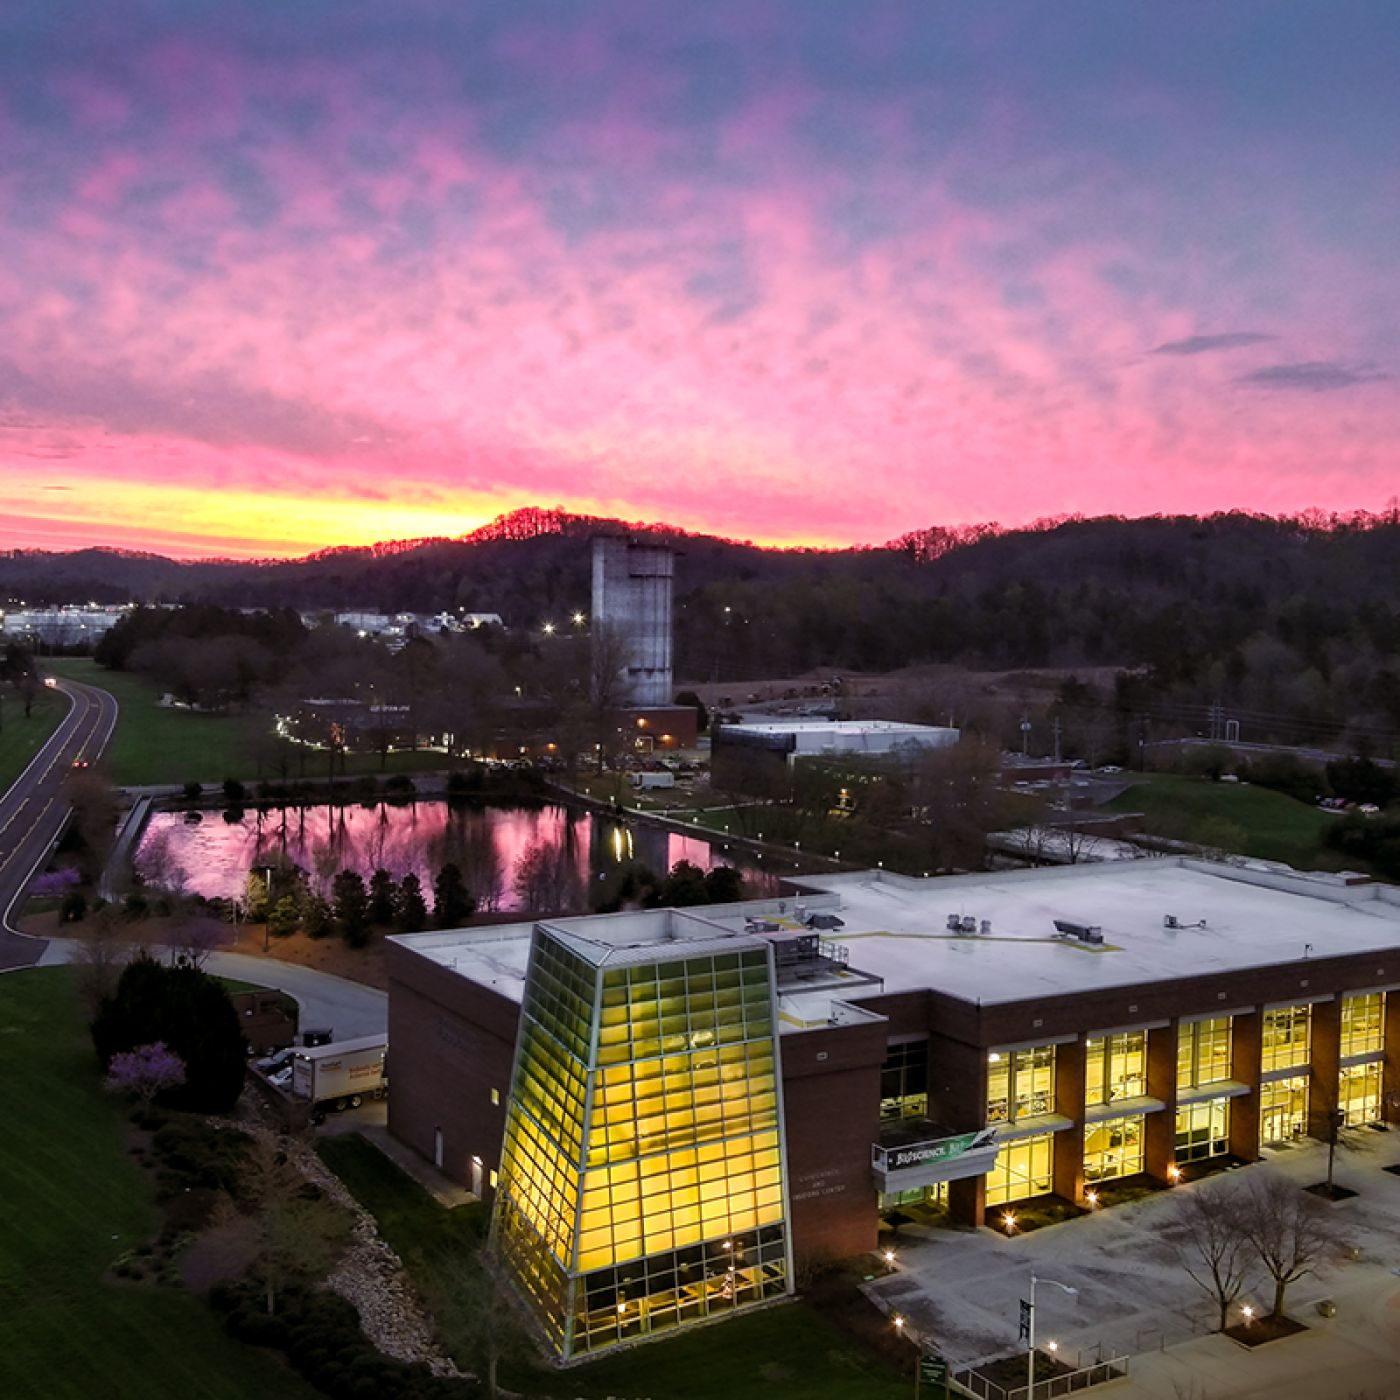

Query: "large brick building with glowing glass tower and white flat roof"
<box><xmin>388</xmin><ymin>858</ymin><xmax>1400</xmax><ymax>1358</ymax></box>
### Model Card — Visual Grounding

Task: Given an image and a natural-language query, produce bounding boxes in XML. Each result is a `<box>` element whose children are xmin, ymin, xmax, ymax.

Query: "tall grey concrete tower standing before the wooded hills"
<box><xmin>592</xmin><ymin>536</ymin><xmax>672</xmax><ymax>707</ymax></box>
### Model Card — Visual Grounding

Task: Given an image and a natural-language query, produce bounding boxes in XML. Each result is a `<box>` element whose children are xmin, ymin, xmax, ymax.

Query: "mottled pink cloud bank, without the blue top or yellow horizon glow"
<box><xmin>0</xmin><ymin>12</ymin><xmax>1396</xmax><ymax>549</ymax></box>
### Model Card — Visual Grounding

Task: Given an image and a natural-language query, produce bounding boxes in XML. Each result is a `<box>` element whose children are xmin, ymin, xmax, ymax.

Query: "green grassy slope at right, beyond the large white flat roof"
<box><xmin>1107</xmin><ymin>774</ymin><xmax>1338</xmax><ymax>869</ymax></box>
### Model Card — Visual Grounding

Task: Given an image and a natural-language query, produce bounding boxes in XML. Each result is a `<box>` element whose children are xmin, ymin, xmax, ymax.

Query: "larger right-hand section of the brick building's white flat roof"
<box><xmin>802</xmin><ymin>858</ymin><xmax>1400</xmax><ymax>1005</ymax></box>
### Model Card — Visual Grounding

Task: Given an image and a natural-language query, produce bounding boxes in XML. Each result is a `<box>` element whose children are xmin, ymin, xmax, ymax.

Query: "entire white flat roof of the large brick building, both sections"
<box><xmin>398</xmin><ymin>857</ymin><xmax>1400</xmax><ymax>1019</ymax></box>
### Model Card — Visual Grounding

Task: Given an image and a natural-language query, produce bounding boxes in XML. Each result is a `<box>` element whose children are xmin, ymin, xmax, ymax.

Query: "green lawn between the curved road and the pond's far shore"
<box><xmin>50</xmin><ymin>657</ymin><xmax>448</xmax><ymax>787</ymax></box>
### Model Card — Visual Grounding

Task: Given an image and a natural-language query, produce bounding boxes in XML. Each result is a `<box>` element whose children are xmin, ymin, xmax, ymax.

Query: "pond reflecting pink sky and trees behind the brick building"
<box><xmin>136</xmin><ymin>801</ymin><xmax>777</xmax><ymax>910</ymax></box>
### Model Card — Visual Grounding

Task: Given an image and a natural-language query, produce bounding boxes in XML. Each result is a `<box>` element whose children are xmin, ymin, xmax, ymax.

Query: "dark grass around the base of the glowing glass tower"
<box><xmin>318</xmin><ymin>1135</ymin><xmax>910</xmax><ymax>1400</ymax></box>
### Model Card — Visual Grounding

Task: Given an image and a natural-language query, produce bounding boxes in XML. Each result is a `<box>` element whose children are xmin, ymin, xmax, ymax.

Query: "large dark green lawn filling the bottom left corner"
<box><xmin>0</xmin><ymin>967</ymin><xmax>318</xmax><ymax>1400</ymax></box>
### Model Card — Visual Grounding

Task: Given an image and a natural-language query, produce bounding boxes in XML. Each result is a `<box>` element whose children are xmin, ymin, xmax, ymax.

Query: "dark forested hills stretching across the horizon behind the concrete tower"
<box><xmin>8</xmin><ymin>511</ymin><xmax>1400</xmax><ymax>706</ymax></box>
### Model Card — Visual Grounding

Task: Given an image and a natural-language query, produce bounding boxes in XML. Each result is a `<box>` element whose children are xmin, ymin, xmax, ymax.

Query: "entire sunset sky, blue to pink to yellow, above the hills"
<box><xmin>0</xmin><ymin>0</ymin><xmax>1400</xmax><ymax>557</ymax></box>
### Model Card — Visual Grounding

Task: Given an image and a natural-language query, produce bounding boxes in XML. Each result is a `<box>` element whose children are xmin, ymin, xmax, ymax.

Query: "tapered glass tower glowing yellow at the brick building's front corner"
<box><xmin>496</xmin><ymin>930</ymin><xmax>788</xmax><ymax>1357</ymax></box>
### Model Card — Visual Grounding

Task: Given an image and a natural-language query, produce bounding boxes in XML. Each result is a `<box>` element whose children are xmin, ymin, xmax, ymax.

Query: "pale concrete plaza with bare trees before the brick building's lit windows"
<box><xmin>865</xmin><ymin>1130</ymin><xmax>1400</xmax><ymax>1400</ymax></box>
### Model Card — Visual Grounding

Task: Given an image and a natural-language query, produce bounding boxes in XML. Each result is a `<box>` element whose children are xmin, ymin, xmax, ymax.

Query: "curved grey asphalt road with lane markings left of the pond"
<box><xmin>0</xmin><ymin>680</ymin><xmax>118</xmax><ymax>972</ymax></box>
